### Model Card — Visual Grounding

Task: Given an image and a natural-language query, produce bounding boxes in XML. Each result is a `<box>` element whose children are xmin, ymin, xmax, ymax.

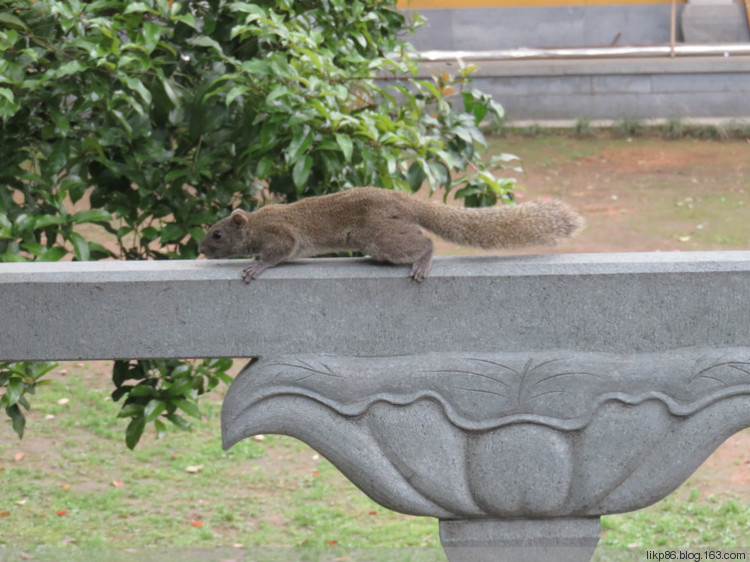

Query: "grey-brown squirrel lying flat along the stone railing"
<box><xmin>199</xmin><ymin>187</ymin><xmax>584</xmax><ymax>283</ymax></box>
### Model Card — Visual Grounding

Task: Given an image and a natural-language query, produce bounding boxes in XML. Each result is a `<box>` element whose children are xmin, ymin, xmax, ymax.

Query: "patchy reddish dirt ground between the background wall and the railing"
<box><xmin>440</xmin><ymin>135</ymin><xmax>750</xmax><ymax>253</ymax></box>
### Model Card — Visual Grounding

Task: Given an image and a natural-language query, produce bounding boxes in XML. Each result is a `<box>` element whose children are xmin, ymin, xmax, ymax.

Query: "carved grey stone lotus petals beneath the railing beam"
<box><xmin>222</xmin><ymin>348</ymin><xmax>750</xmax><ymax>519</ymax></box>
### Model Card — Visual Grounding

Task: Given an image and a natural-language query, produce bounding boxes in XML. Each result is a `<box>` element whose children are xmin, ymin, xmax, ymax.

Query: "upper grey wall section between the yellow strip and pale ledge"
<box><xmin>405</xmin><ymin>2</ymin><xmax>750</xmax><ymax>51</ymax></box>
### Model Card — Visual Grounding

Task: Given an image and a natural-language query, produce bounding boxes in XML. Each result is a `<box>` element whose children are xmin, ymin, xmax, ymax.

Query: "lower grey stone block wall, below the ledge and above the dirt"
<box><xmin>422</xmin><ymin>56</ymin><xmax>750</xmax><ymax>121</ymax></box>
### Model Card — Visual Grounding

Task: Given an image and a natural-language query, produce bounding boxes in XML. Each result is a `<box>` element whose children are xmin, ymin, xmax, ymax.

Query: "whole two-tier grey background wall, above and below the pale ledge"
<box><xmin>412</xmin><ymin>1</ymin><xmax>750</xmax><ymax>121</ymax></box>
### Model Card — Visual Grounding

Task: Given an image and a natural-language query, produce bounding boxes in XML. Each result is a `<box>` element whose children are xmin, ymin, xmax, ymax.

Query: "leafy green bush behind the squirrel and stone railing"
<box><xmin>0</xmin><ymin>0</ymin><xmax>513</xmax><ymax>446</ymax></box>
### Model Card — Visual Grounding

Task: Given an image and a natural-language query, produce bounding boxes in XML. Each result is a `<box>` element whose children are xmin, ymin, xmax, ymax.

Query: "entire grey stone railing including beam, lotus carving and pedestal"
<box><xmin>0</xmin><ymin>252</ymin><xmax>750</xmax><ymax>560</ymax></box>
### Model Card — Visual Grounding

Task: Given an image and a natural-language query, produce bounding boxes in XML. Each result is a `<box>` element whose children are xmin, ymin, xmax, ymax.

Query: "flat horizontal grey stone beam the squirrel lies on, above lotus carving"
<box><xmin>0</xmin><ymin>252</ymin><xmax>750</xmax><ymax>360</ymax></box>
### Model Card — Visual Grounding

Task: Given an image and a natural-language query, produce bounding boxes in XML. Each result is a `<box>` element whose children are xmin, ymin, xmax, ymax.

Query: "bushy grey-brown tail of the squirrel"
<box><xmin>417</xmin><ymin>200</ymin><xmax>584</xmax><ymax>248</ymax></box>
